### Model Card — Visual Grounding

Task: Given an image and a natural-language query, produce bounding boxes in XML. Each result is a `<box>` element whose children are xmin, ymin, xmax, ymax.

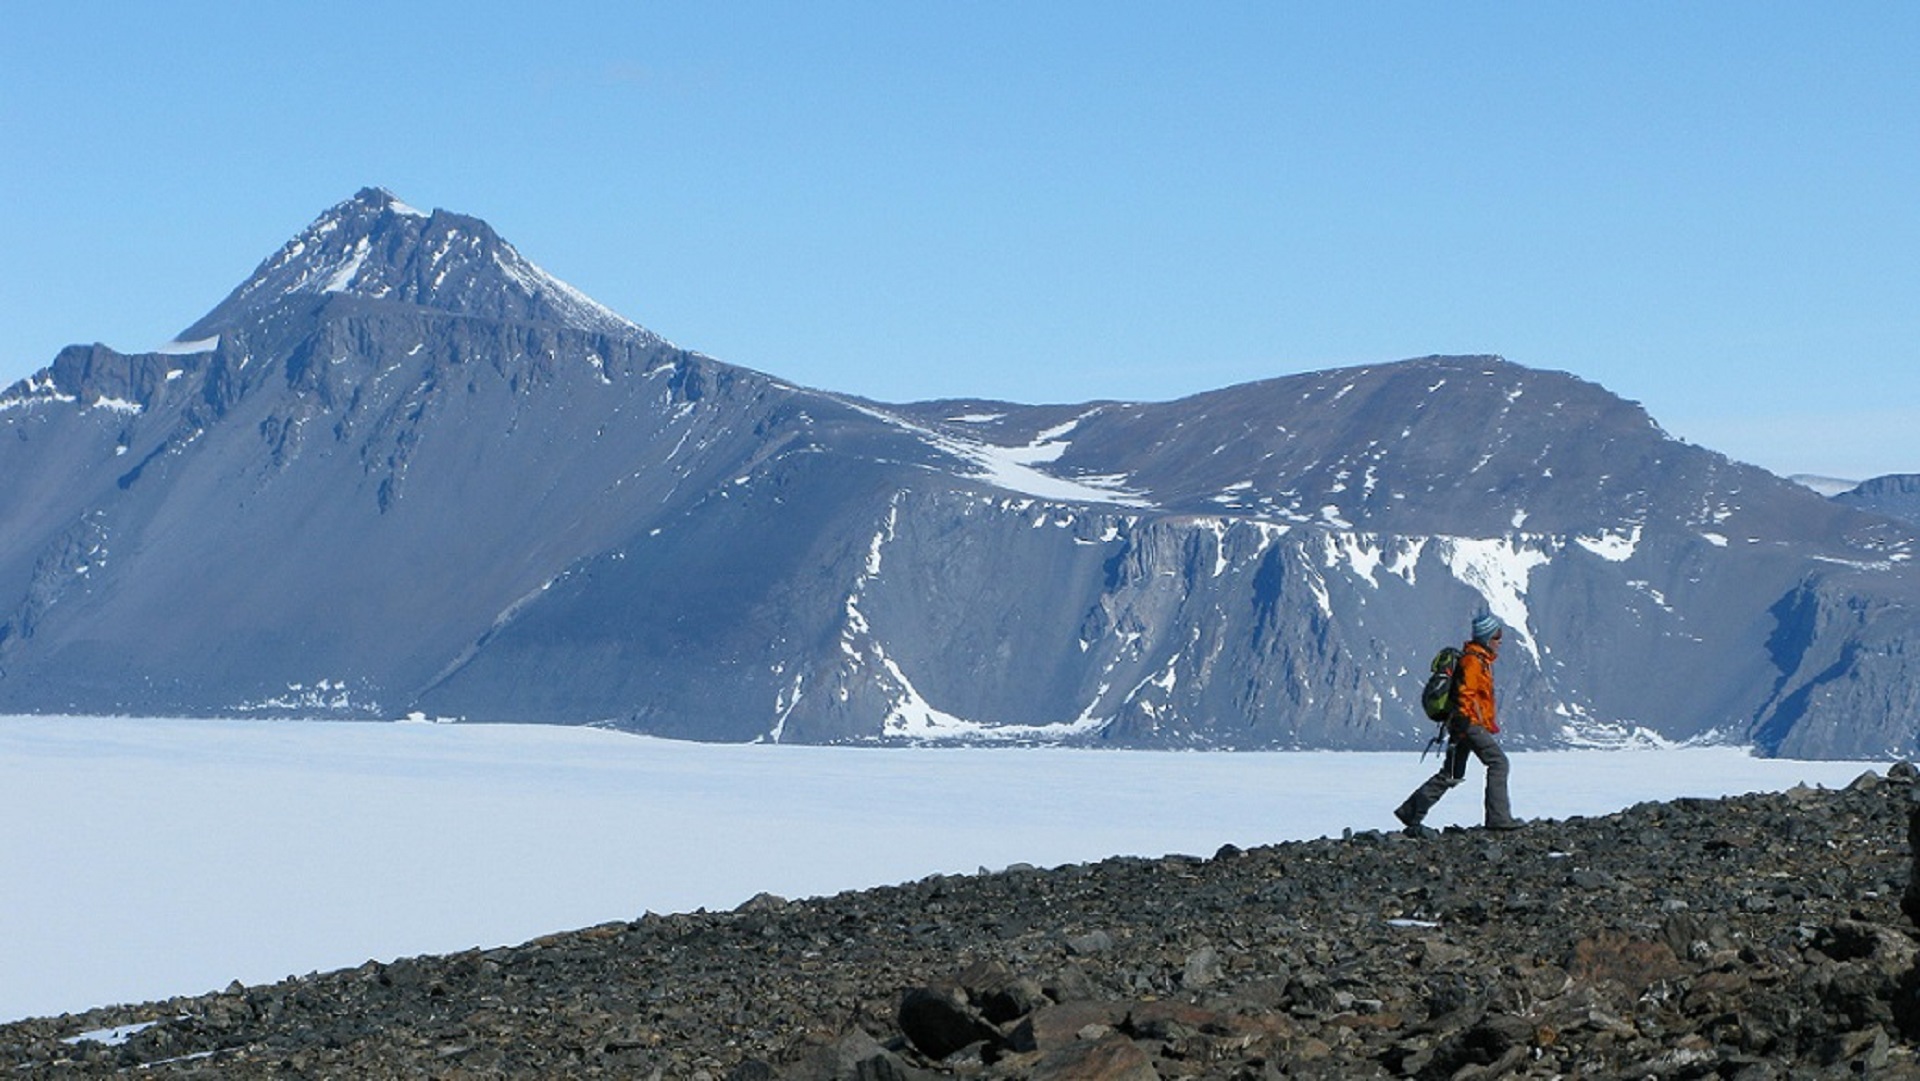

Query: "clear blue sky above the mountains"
<box><xmin>0</xmin><ymin>0</ymin><xmax>1920</xmax><ymax>478</ymax></box>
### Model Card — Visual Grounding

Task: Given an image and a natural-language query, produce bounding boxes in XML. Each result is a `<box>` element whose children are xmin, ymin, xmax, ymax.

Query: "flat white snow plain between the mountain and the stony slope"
<box><xmin>0</xmin><ymin>718</ymin><xmax>1885</xmax><ymax>1020</ymax></box>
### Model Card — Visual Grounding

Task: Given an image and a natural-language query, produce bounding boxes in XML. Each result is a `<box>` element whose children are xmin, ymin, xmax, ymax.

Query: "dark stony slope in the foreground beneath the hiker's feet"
<box><xmin>11</xmin><ymin>764</ymin><xmax>1920</xmax><ymax>1081</ymax></box>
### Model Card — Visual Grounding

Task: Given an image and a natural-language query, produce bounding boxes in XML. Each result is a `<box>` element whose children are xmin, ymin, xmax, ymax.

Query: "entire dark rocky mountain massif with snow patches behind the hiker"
<box><xmin>0</xmin><ymin>190</ymin><xmax>1920</xmax><ymax>757</ymax></box>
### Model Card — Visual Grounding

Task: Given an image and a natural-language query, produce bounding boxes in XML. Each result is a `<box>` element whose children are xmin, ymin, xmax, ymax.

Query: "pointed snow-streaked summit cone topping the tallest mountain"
<box><xmin>177</xmin><ymin>186</ymin><xmax>655</xmax><ymax>344</ymax></box>
